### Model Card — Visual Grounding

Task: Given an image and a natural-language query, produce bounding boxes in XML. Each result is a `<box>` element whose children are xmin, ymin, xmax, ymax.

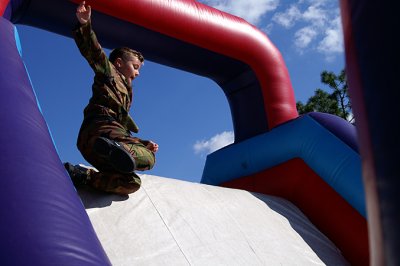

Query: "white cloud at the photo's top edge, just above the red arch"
<box><xmin>199</xmin><ymin>0</ymin><xmax>279</xmax><ymax>24</ymax></box>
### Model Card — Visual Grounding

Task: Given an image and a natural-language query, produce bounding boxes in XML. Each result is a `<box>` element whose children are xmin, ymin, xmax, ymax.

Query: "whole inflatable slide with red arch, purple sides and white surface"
<box><xmin>0</xmin><ymin>0</ymin><xmax>398</xmax><ymax>265</ymax></box>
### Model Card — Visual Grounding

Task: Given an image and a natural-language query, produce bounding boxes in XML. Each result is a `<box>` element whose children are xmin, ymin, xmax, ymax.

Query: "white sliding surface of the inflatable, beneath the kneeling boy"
<box><xmin>78</xmin><ymin>175</ymin><xmax>348</xmax><ymax>266</ymax></box>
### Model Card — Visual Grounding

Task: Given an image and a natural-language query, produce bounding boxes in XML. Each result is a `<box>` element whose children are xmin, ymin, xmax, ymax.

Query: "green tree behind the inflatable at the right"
<box><xmin>296</xmin><ymin>70</ymin><xmax>353</xmax><ymax>122</ymax></box>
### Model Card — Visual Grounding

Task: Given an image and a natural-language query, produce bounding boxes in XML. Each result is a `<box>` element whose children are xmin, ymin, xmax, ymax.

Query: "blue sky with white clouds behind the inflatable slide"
<box><xmin>17</xmin><ymin>0</ymin><xmax>344</xmax><ymax>182</ymax></box>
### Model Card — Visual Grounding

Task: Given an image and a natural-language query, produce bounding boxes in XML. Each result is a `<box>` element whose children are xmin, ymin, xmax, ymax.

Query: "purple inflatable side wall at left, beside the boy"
<box><xmin>0</xmin><ymin>17</ymin><xmax>110</xmax><ymax>265</ymax></box>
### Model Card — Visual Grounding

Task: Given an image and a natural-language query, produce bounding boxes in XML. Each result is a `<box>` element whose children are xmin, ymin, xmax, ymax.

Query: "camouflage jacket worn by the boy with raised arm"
<box><xmin>72</xmin><ymin>21</ymin><xmax>139</xmax><ymax>133</ymax></box>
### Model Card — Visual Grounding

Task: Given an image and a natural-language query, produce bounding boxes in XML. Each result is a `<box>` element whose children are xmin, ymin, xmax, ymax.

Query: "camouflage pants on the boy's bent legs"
<box><xmin>77</xmin><ymin>118</ymin><xmax>155</xmax><ymax>195</ymax></box>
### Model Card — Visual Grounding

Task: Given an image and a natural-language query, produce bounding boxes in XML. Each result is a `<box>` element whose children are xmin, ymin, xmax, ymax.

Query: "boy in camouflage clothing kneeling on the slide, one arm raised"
<box><xmin>64</xmin><ymin>1</ymin><xmax>158</xmax><ymax>195</ymax></box>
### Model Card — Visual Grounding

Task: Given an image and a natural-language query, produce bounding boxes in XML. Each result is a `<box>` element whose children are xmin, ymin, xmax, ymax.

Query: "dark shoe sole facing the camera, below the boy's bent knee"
<box><xmin>93</xmin><ymin>137</ymin><xmax>136</xmax><ymax>174</ymax></box>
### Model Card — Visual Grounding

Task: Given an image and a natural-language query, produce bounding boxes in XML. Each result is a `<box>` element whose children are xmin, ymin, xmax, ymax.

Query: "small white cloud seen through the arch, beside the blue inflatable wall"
<box><xmin>193</xmin><ymin>131</ymin><xmax>234</xmax><ymax>154</ymax></box>
